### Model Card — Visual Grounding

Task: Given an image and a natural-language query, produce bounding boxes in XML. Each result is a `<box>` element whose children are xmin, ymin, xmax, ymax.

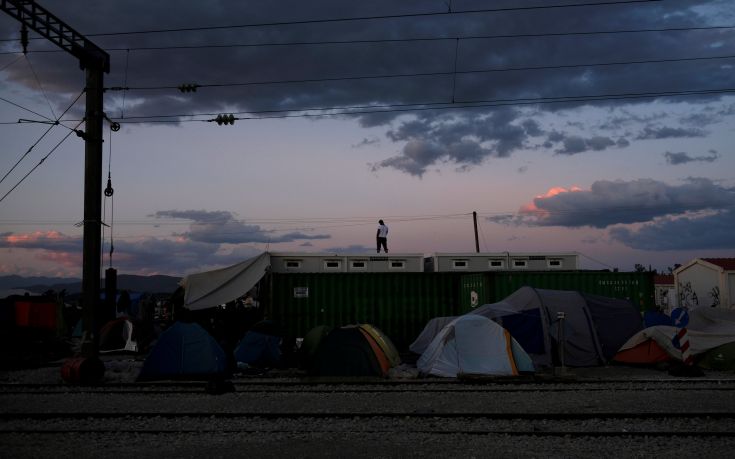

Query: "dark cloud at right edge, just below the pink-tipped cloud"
<box><xmin>610</xmin><ymin>210</ymin><xmax>735</xmax><ymax>250</ymax></box>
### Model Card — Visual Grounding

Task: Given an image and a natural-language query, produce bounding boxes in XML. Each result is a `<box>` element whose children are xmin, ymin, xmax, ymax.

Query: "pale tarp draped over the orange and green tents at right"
<box><xmin>620</xmin><ymin>308</ymin><xmax>735</xmax><ymax>360</ymax></box>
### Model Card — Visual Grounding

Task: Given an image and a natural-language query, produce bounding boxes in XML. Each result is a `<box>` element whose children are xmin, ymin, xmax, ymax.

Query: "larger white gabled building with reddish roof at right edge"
<box><xmin>674</xmin><ymin>258</ymin><xmax>735</xmax><ymax>309</ymax></box>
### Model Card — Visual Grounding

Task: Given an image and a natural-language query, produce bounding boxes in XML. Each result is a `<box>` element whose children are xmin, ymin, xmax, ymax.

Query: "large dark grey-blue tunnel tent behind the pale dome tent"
<box><xmin>411</xmin><ymin>287</ymin><xmax>642</xmax><ymax>367</ymax></box>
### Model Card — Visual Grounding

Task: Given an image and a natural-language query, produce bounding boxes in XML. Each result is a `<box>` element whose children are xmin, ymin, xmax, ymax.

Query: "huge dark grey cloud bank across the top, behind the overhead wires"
<box><xmin>0</xmin><ymin>0</ymin><xmax>735</xmax><ymax>174</ymax></box>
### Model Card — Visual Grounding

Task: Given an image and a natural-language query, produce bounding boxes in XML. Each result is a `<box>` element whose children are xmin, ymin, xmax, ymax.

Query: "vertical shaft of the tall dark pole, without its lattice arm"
<box><xmin>82</xmin><ymin>62</ymin><xmax>104</xmax><ymax>357</ymax></box>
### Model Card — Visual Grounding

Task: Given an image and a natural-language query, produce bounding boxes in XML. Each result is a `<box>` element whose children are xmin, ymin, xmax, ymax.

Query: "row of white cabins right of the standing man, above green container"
<box><xmin>424</xmin><ymin>252</ymin><xmax>579</xmax><ymax>272</ymax></box>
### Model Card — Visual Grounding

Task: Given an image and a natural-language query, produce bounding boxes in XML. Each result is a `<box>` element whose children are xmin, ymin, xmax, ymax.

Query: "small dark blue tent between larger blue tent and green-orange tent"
<box><xmin>234</xmin><ymin>321</ymin><xmax>283</xmax><ymax>367</ymax></box>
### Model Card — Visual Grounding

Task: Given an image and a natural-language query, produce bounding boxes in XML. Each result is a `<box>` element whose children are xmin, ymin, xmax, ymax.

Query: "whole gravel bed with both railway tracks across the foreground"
<box><xmin>0</xmin><ymin>379</ymin><xmax>735</xmax><ymax>458</ymax></box>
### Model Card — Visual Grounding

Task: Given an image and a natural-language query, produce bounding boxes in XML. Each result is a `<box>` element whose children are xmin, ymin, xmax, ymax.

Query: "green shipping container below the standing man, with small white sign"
<box><xmin>266</xmin><ymin>273</ymin><xmax>459</xmax><ymax>351</ymax></box>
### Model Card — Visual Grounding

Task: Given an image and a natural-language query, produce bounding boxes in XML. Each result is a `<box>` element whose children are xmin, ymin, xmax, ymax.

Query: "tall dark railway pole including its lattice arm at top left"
<box><xmin>0</xmin><ymin>0</ymin><xmax>110</xmax><ymax>357</ymax></box>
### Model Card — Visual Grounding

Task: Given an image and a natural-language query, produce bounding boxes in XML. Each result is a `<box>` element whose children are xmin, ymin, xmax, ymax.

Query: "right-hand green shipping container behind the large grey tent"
<box><xmin>486</xmin><ymin>271</ymin><xmax>655</xmax><ymax>312</ymax></box>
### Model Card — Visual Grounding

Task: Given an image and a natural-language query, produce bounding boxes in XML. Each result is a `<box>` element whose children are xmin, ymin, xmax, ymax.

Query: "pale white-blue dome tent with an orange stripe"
<box><xmin>416</xmin><ymin>314</ymin><xmax>534</xmax><ymax>377</ymax></box>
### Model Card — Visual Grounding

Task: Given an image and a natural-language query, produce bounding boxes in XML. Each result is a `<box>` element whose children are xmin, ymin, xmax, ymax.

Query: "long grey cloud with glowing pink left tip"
<box><xmin>488</xmin><ymin>178</ymin><xmax>735</xmax><ymax>228</ymax></box>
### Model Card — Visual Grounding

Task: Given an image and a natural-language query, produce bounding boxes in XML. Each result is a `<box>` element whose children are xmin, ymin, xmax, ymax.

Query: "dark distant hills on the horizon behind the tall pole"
<box><xmin>0</xmin><ymin>274</ymin><xmax>181</xmax><ymax>295</ymax></box>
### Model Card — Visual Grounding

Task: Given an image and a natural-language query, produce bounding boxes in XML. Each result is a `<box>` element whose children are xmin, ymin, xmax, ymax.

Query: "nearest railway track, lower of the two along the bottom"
<box><xmin>0</xmin><ymin>412</ymin><xmax>735</xmax><ymax>438</ymax></box>
